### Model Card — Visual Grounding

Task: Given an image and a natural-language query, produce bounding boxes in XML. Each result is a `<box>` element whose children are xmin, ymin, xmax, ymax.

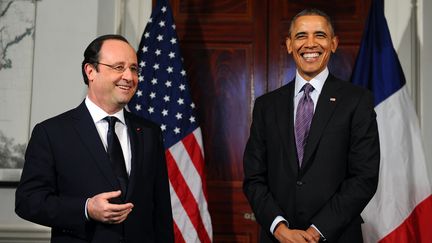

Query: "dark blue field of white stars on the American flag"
<box><xmin>129</xmin><ymin>2</ymin><xmax>198</xmax><ymax>148</ymax></box>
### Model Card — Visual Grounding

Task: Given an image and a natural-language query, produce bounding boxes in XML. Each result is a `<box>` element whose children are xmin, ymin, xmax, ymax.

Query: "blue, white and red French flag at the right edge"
<box><xmin>351</xmin><ymin>0</ymin><xmax>432</xmax><ymax>243</ymax></box>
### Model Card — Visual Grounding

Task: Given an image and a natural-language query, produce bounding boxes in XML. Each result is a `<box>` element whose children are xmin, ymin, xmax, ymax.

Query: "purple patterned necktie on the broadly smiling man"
<box><xmin>294</xmin><ymin>83</ymin><xmax>314</xmax><ymax>167</ymax></box>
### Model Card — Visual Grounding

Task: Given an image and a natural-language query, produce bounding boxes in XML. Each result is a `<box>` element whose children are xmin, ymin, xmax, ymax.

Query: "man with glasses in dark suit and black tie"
<box><xmin>15</xmin><ymin>35</ymin><xmax>174</xmax><ymax>243</ymax></box>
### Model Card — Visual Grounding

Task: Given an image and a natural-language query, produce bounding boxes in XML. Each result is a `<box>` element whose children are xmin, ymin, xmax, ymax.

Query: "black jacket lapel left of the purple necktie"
<box><xmin>276</xmin><ymin>81</ymin><xmax>298</xmax><ymax>173</ymax></box>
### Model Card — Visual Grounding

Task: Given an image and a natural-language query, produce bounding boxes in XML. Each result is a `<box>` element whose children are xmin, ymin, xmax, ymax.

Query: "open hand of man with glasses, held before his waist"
<box><xmin>87</xmin><ymin>191</ymin><xmax>133</xmax><ymax>224</ymax></box>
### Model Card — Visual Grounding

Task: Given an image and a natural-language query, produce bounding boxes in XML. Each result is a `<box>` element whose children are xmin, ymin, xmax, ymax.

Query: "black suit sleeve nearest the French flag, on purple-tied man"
<box><xmin>311</xmin><ymin>91</ymin><xmax>380</xmax><ymax>242</ymax></box>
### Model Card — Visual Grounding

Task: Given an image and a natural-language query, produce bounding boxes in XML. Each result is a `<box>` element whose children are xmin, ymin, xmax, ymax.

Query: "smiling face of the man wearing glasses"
<box><xmin>85</xmin><ymin>40</ymin><xmax>138</xmax><ymax>114</ymax></box>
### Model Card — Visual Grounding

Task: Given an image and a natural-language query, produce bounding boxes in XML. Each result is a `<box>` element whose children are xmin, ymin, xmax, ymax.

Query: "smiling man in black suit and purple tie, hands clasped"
<box><xmin>243</xmin><ymin>9</ymin><xmax>380</xmax><ymax>243</ymax></box>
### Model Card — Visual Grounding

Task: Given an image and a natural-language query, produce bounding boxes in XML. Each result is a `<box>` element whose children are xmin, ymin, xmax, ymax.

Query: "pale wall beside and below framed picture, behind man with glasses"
<box><xmin>0</xmin><ymin>0</ymin><xmax>151</xmax><ymax>243</ymax></box>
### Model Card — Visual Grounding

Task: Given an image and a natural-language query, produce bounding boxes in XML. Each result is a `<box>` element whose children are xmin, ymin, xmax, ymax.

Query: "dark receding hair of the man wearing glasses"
<box><xmin>81</xmin><ymin>34</ymin><xmax>129</xmax><ymax>85</ymax></box>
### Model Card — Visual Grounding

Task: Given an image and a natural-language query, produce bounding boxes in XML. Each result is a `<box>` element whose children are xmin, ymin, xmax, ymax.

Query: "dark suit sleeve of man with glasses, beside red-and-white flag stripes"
<box><xmin>154</xmin><ymin>129</ymin><xmax>174</xmax><ymax>242</ymax></box>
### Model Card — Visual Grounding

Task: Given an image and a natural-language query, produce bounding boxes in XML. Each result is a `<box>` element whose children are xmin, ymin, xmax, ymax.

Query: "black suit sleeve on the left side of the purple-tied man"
<box><xmin>243</xmin><ymin>98</ymin><xmax>285</xmax><ymax>232</ymax></box>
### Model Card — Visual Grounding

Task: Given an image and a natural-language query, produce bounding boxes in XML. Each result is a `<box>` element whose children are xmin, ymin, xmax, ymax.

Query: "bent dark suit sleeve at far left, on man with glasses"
<box><xmin>15</xmin><ymin>124</ymin><xmax>86</xmax><ymax>237</ymax></box>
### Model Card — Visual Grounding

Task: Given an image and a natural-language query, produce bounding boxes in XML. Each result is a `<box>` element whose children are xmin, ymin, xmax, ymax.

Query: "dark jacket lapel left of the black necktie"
<box><xmin>74</xmin><ymin>102</ymin><xmax>119</xmax><ymax>189</ymax></box>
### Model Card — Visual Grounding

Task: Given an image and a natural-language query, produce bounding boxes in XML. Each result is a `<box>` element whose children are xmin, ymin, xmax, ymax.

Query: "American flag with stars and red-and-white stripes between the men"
<box><xmin>128</xmin><ymin>0</ymin><xmax>212</xmax><ymax>243</ymax></box>
